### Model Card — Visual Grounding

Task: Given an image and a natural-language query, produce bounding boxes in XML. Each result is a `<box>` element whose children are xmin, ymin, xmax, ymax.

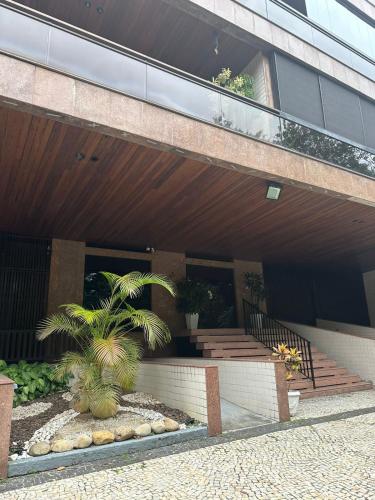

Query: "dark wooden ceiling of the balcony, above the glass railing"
<box><xmin>15</xmin><ymin>0</ymin><xmax>262</xmax><ymax>80</ymax></box>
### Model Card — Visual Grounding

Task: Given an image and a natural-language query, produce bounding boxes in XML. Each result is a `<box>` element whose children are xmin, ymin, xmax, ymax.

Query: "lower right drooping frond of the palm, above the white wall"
<box><xmin>128</xmin><ymin>306</ymin><xmax>171</xmax><ymax>350</ymax></box>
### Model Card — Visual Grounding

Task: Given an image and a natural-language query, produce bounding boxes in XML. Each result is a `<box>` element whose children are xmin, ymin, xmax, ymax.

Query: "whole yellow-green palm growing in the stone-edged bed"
<box><xmin>37</xmin><ymin>272</ymin><xmax>175</xmax><ymax>418</ymax></box>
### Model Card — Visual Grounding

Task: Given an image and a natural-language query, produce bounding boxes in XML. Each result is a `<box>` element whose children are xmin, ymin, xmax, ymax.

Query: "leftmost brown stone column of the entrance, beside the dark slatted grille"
<box><xmin>47</xmin><ymin>239</ymin><xmax>85</xmax><ymax>314</ymax></box>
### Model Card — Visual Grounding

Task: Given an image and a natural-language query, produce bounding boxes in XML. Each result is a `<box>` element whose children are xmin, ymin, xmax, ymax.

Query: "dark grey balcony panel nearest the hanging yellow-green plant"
<box><xmin>275</xmin><ymin>54</ymin><xmax>324</xmax><ymax>128</ymax></box>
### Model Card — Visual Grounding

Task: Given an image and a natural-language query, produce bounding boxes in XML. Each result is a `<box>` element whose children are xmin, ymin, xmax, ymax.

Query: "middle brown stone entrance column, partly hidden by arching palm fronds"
<box><xmin>151</xmin><ymin>251</ymin><xmax>186</xmax><ymax>355</ymax></box>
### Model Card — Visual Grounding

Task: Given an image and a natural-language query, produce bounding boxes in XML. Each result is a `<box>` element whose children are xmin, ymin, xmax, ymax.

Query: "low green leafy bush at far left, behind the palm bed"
<box><xmin>0</xmin><ymin>360</ymin><xmax>67</xmax><ymax>406</ymax></box>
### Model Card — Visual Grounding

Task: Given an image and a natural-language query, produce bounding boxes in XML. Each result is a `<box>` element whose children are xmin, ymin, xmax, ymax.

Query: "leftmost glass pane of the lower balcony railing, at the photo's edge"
<box><xmin>0</xmin><ymin>7</ymin><xmax>51</xmax><ymax>64</ymax></box>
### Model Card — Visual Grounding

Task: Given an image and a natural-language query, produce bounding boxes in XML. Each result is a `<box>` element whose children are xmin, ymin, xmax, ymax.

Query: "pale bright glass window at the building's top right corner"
<box><xmin>284</xmin><ymin>0</ymin><xmax>375</xmax><ymax>59</ymax></box>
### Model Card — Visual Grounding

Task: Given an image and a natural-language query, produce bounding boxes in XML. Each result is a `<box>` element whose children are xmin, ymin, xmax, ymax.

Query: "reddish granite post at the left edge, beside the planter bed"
<box><xmin>0</xmin><ymin>375</ymin><xmax>14</xmax><ymax>479</ymax></box>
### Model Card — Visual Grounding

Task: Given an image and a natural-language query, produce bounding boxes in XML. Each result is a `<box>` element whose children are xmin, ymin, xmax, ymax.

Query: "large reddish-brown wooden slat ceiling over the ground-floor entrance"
<box><xmin>0</xmin><ymin>108</ymin><xmax>375</xmax><ymax>274</ymax></box>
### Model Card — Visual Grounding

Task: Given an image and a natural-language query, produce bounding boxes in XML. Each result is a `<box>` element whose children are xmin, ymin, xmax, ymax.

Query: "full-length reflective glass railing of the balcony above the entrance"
<box><xmin>0</xmin><ymin>1</ymin><xmax>375</xmax><ymax>178</ymax></box>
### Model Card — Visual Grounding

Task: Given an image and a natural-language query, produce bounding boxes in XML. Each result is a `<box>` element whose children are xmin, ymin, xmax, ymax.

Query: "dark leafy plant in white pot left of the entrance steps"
<box><xmin>177</xmin><ymin>279</ymin><xmax>209</xmax><ymax>330</ymax></box>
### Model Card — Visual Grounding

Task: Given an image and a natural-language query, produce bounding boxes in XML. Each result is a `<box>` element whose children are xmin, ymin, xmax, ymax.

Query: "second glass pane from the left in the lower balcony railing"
<box><xmin>48</xmin><ymin>28</ymin><xmax>146</xmax><ymax>98</ymax></box>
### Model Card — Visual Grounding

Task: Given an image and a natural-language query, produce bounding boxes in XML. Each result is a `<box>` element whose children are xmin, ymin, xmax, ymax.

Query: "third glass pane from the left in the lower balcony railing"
<box><xmin>147</xmin><ymin>66</ymin><xmax>221</xmax><ymax>123</ymax></box>
